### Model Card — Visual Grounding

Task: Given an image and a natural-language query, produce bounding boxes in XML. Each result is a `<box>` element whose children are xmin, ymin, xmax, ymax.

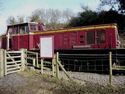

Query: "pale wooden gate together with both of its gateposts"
<box><xmin>0</xmin><ymin>49</ymin><xmax>26</xmax><ymax>77</ymax></box>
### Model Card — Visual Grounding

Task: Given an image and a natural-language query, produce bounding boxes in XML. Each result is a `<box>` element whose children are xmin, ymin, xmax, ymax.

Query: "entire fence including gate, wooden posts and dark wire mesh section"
<box><xmin>0</xmin><ymin>49</ymin><xmax>125</xmax><ymax>85</ymax></box>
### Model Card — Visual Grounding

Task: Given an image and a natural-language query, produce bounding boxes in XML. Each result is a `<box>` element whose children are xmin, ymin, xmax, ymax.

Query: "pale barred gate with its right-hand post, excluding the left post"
<box><xmin>4</xmin><ymin>49</ymin><xmax>25</xmax><ymax>75</ymax></box>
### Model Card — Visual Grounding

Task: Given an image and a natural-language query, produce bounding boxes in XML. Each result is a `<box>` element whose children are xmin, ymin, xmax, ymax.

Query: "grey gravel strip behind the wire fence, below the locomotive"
<box><xmin>44</xmin><ymin>70</ymin><xmax>125</xmax><ymax>85</ymax></box>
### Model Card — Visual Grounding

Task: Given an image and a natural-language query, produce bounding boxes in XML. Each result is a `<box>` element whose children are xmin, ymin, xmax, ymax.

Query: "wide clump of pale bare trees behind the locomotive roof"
<box><xmin>27</xmin><ymin>8</ymin><xmax>74</xmax><ymax>29</ymax></box>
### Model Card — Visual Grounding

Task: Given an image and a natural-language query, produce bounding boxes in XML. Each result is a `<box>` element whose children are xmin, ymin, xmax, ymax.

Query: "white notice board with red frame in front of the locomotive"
<box><xmin>40</xmin><ymin>35</ymin><xmax>54</xmax><ymax>58</ymax></box>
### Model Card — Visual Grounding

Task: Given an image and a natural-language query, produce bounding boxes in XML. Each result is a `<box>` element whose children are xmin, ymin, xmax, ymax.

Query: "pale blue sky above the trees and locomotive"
<box><xmin>0</xmin><ymin>0</ymin><xmax>110</xmax><ymax>34</ymax></box>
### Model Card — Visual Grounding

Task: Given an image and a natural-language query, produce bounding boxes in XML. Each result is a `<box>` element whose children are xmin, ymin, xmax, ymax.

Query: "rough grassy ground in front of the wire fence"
<box><xmin>0</xmin><ymin>69</ymin><xmax>125</xmax><ymax>94</ymax></box>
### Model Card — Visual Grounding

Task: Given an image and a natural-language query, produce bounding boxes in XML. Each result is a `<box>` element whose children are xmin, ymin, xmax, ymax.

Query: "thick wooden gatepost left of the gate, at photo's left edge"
<box><xmin>0</xmin><ymin>49</ymin><xmax>5</xmax><ymax>78</ymax></box>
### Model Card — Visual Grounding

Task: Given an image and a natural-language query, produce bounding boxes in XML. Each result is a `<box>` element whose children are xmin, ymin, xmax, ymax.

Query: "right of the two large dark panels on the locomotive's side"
<box><xmin>97</xmin><ymin>31</ymin><xmax>105</xmax><ymax>44</ymax></box>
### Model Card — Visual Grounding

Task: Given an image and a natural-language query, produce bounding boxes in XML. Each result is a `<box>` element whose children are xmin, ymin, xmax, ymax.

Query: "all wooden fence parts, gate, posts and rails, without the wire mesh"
<box><xmin>0</xmin><ymin>49</ymin><xmax>125</xmax><ymax>85</ymax></box>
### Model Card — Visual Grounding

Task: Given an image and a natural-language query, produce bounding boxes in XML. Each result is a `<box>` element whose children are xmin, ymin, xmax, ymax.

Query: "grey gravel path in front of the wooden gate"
<box><xmin>0</xmin><ymin>73</ymin><xmax>27</xmax><ymax>88</ymax></box>
